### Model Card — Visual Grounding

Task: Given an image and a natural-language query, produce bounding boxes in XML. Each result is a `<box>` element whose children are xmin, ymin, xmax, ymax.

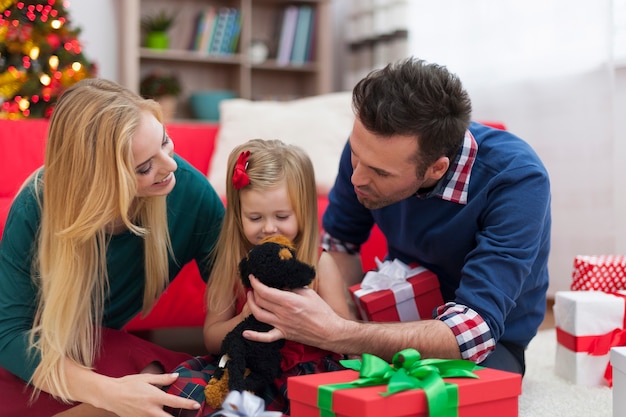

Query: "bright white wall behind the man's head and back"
<box><xmin>402</xmin><ymin>0</ymin><xmax>626</xmax><ymax>295</ymax></box>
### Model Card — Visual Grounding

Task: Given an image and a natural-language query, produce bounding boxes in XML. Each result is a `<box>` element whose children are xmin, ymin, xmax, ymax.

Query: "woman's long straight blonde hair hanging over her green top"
<box><xmin>30</xmin><ymin>79</ymin><xmax>171</xmax><ymax>401</ymax></box>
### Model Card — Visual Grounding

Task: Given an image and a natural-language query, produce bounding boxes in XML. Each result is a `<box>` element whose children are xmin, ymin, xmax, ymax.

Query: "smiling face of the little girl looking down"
<box><xmin>239</xmin><ymin>182</ymin><xmax>298</xmax><ymax>245</ymax></box>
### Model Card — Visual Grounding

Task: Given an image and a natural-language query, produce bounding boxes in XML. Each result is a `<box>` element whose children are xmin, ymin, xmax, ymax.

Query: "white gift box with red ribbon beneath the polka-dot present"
<box><xmin>554</xmin><ymin>291</ymin><xmax>626</xmax><ymax>386</ymax></box>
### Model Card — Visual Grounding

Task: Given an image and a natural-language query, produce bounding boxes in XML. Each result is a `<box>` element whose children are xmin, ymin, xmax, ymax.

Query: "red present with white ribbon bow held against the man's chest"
<box><xmin>350</xmin><ymin>259</ymin><xmax>443</xmax><ymax>322</ymax></box>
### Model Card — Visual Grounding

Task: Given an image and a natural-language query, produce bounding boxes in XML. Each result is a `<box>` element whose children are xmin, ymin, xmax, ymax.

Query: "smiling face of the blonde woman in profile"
<box><xmin>132</xmin><ymin>112</ymin><xmax>178</xmax><ymax>197</ymax></box>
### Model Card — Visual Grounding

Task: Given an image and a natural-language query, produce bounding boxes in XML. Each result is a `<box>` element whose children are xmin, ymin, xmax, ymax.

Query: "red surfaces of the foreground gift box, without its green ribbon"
<box><xmin>287</xmin><ymin>368</ymin><xmax>522</xmax><ymax>417</ymax></box>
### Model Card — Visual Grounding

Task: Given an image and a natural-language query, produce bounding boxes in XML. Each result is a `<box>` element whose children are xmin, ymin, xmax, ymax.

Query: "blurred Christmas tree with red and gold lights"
<box><xmin>0</xmin><ymin>0</ymin><xmax>96</xmax><ymax>119</ymax></box>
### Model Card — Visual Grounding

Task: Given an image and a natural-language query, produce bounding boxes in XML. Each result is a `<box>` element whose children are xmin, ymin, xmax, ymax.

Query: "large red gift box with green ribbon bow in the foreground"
<box><xmin>287</xmin><ymin>349</ymin><xmax>522</xmax><ymax>417</ymax></box>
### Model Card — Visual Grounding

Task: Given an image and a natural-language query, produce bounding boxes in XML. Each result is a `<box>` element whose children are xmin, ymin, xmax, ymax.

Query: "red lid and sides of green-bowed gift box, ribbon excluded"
<box><xmin>288</xmin><ymin>368</ymin><xmax>522</xmax><ymax>417</ymax></box>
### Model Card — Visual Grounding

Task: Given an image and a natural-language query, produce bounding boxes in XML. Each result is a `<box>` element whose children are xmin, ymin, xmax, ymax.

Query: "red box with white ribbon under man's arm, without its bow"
<box><xmin>350</xmin><ymin>260</ymin><xmax>443</xmax><ymax>322</ymax></box>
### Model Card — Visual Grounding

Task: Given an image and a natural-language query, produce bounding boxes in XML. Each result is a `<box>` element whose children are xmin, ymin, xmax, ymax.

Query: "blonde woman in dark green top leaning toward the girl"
<box><xmin>0</xmin><ymin>79</ymin><xmax>224</xmax><ymax>417</ymax></box>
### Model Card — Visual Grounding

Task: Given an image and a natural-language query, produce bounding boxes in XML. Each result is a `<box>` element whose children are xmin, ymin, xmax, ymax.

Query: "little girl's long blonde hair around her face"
<box><xmin>207</xmin><ymin>139</ymin><xmax>319</xmax><ymax>312</ymax></box>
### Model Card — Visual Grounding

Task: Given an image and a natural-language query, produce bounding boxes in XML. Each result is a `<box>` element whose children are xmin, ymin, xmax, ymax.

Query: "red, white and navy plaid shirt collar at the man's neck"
<box><xmin>415</xmin><ymin>130</ymin><xmax>478</xmax><ymax>205</ymax></box>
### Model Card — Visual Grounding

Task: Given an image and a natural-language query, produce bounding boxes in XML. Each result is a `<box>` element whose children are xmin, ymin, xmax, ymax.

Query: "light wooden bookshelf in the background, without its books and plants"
<box><xmin>119</xmin><ymin>0</ymin><xmax>332</xmax><ymax>119</ymax></box>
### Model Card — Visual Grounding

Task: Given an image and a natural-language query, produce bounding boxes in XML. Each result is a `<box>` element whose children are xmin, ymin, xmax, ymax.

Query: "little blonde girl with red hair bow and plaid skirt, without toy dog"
<box><xmin>167</xmin><ymin>139</ymin><xmax>349</xmax><ymax>417</ymax></box>
